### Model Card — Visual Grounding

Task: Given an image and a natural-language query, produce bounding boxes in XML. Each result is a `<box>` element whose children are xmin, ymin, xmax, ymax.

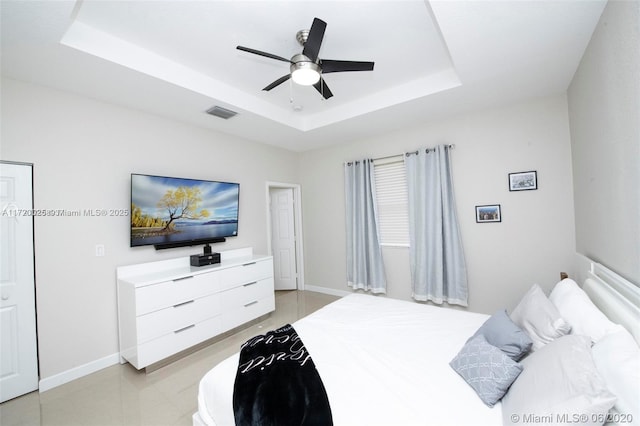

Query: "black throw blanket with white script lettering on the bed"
<box><xmin>233</xmin><ymin>324</ymin><xmax>333</xmax><ymax>426</ymax></box>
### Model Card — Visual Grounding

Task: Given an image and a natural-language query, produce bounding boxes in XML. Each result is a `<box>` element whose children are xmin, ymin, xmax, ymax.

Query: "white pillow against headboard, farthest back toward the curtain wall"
<box><xmin>549</xmin><ymin>278</ymin><xmax>621</xmax><ymax>343</ymax></box>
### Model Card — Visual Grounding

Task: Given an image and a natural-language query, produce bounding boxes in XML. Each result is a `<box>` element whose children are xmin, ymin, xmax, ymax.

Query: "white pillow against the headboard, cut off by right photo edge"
<box><xmin>591</xmin><ymin>327</ymin><xmax>640</xmax><ymax>424</ymax></box>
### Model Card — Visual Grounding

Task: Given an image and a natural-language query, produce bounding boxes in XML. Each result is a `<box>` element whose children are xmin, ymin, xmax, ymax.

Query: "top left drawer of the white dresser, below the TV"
<box><xmin>135</xmin><ymin>271</ymin><xmax>219</xmax><ymax>315</ymax></box>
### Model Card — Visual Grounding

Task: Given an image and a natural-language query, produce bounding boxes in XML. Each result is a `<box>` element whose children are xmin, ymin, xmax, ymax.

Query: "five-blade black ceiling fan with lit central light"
<box><xmin>237</xmin><ymin>18</ymin><xmax>374</xmax><ymax>99</ymax></box>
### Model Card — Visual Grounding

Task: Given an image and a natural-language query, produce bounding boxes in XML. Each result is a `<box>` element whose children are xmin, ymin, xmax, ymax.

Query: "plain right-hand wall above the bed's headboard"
<box><xmin>568</xmin><ymin>1</ymin><xmax>640</xmax><ymax>285</ymax></box>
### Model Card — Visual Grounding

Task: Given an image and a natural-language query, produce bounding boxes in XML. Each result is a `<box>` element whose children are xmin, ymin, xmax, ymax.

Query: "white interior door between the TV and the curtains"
<box><xmin>269</xmin><ymin>188</ymin><xmax>298</xmax><ymax>290</ymax></box>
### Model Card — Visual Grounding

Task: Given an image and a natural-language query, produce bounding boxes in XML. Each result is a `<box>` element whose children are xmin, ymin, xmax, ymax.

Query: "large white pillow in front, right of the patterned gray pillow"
<box><xmin>502</xmin><ymin>334</ymin><xmax>616</xmax><ymax>426</ymax></box>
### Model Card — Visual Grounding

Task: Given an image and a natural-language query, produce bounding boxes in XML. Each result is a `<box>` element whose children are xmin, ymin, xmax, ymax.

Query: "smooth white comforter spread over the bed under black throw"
<box><xmin>196</xmin><ymin>294</ymin><xmax>502</xmax><ymax>426</ymax></box>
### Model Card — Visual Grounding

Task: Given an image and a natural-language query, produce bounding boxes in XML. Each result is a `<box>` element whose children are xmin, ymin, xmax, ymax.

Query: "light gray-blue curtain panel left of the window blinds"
<box><xmin>344</xmin><ymin>160</ymin><xmax>387</xmax><ymax>293</ymax></box>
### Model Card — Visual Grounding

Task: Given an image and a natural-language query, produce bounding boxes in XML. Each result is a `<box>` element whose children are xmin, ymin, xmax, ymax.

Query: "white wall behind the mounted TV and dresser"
<box><xmin>1</xmin><ymin>79</ymin><xmax>298</xmax><ymax>379</ymax></box>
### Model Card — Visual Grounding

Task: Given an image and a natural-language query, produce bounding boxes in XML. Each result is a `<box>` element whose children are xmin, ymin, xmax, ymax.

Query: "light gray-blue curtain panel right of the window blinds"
<box><xmin>404</xmin><ymin>145</ymin><xmax>467</xmax><ymax>306</ymax></box>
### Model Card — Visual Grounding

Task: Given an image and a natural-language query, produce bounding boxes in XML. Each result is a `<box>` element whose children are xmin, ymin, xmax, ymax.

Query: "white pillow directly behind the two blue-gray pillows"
<box><xmin>509</xmin><ymin>284</ymin><xmax>571</xmax><ymax>351</ymax></box>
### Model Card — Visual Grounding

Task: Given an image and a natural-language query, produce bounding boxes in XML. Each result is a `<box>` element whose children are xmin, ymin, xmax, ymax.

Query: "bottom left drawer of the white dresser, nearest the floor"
<box><xmin>135</xmin><ymin>316</ymin><xmax>222</xmax><ymax>369</ymax></box>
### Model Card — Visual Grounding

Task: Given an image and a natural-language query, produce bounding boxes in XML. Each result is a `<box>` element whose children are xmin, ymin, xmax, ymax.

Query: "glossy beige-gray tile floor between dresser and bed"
<box><xmin>0</xmin><ymin>291</ymin><xmax>338</xmax><ymax>426</ymax></box>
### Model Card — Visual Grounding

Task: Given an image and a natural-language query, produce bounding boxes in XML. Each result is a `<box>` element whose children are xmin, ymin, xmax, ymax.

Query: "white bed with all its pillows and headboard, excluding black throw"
<box><xmin>193</xmin><ymin>256</ymin><xmax>640</xmax><ymax>426</ymax></box>
